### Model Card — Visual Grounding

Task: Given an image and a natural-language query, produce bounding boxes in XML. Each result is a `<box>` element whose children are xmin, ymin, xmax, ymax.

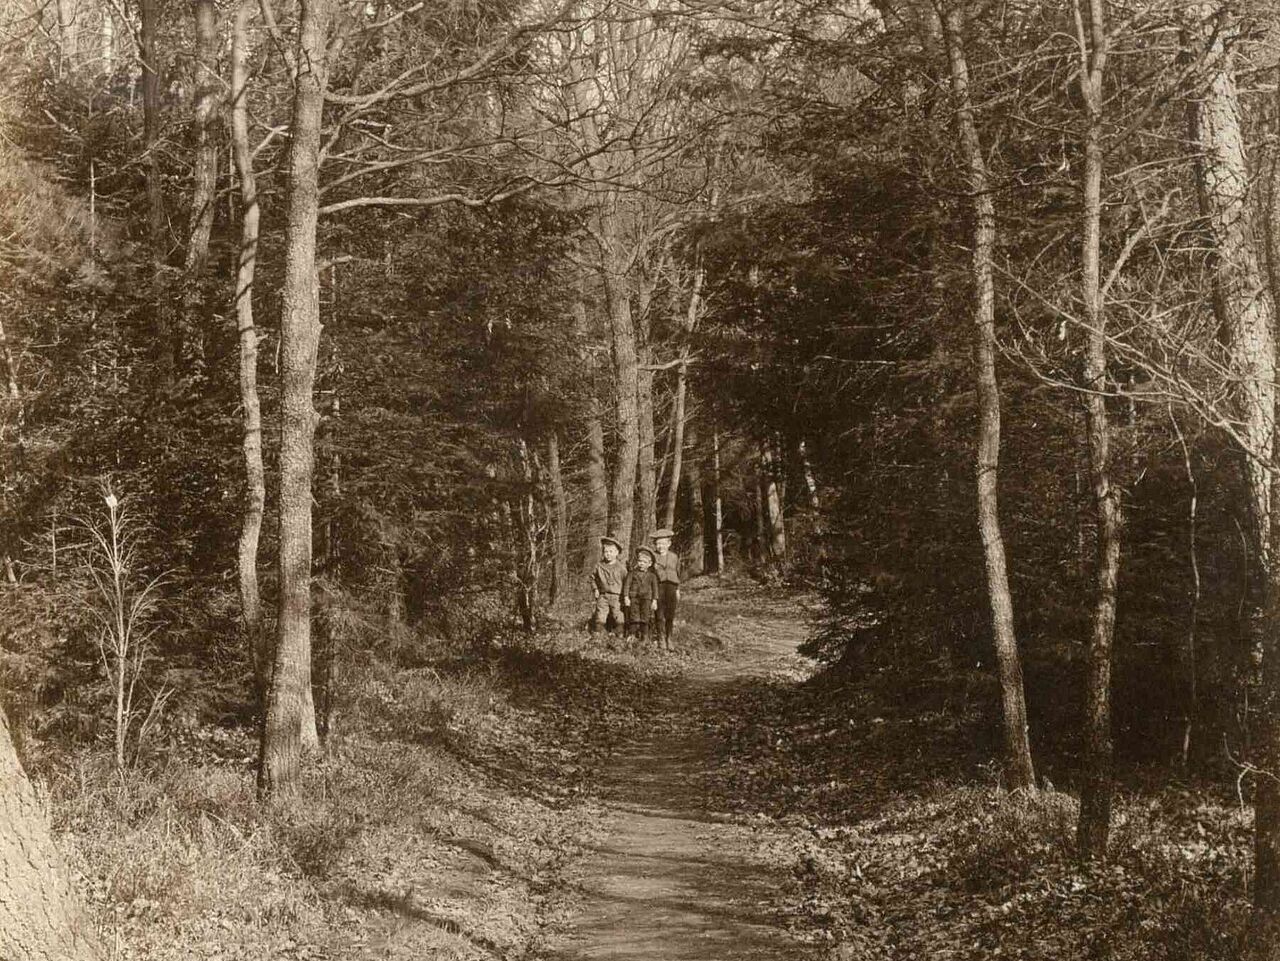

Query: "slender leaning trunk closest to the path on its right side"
<box><xmin>942</xmin><ymin>0</ymin><xmax>1036</xmax><ymax>791</ymax></box>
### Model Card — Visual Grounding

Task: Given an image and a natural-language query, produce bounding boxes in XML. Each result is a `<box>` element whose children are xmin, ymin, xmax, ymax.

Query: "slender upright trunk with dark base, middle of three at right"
<box><xmin>1076</xmin><ymin>0</ymin><xmax>1120</xmax><ymax>860</ymax></box>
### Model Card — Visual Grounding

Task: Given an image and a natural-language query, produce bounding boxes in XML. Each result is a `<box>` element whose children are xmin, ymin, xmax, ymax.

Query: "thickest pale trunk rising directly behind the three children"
<box><xmin>604</xmin><ymin>264</ymin><xmax>640</xmax><ymax>557</ymax></box>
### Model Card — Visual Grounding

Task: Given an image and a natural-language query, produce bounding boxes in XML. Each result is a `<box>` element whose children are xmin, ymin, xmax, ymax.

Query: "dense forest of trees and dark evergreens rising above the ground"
<box><xmin>0</xmin><ymin>0</ymin><xmax>1280</xmax><ymax>957</ymax></box>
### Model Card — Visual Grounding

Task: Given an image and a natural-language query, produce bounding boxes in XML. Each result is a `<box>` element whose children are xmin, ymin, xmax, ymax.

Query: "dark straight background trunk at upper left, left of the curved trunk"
<box><xmin>140</xmin><ymin>0</ymin><xmax>170</xmax><ymax>388</ymax></box>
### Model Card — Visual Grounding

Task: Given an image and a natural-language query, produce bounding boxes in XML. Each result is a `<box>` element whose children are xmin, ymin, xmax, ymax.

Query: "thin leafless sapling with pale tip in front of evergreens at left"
<box><xmin>78</xmin><ymin>485</ymin><xmax>172</xmax><ymax>770</ymax></box>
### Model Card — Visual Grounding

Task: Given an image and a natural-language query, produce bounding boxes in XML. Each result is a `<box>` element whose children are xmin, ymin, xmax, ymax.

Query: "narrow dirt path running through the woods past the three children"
<box><xmin>548</xmin><ymin>587</ymin><xmax>812</xmax><ymax>961</ymax></box>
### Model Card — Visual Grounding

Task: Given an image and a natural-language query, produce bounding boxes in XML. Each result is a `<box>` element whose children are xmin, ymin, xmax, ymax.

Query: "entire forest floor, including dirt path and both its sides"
<box><xmin>46</xmin><ymin>580</ymin><xmax>1251</xmax><ymax>961</ymax></box>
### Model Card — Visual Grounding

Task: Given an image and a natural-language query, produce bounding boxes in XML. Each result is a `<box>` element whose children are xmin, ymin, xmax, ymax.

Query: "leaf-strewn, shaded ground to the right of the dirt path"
<box><xmin>713</xmin><ymin>593</ymin><xmax>1252</xmax><ymax>961</ymax></box>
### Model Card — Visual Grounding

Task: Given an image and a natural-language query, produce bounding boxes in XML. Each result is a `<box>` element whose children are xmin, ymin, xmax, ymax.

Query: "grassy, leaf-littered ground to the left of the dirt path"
<box><xmin>45</xmin><ymin>619</ymin><xmax>652</xmax><ymax>961</ymax></box>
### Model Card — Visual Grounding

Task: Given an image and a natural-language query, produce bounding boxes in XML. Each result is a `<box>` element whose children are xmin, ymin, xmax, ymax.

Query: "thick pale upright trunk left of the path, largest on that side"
<box><xmin>259</xmin><ymin>0</ymin><xmax>333</xmax><ymax>795</ymax></box>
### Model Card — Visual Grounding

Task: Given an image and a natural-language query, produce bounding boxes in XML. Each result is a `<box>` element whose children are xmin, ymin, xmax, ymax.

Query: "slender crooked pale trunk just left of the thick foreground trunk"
<box><xmin>232</xmin><ymin>0</ymin><xmax>270</xmax><ymax>708</ymax></box>
